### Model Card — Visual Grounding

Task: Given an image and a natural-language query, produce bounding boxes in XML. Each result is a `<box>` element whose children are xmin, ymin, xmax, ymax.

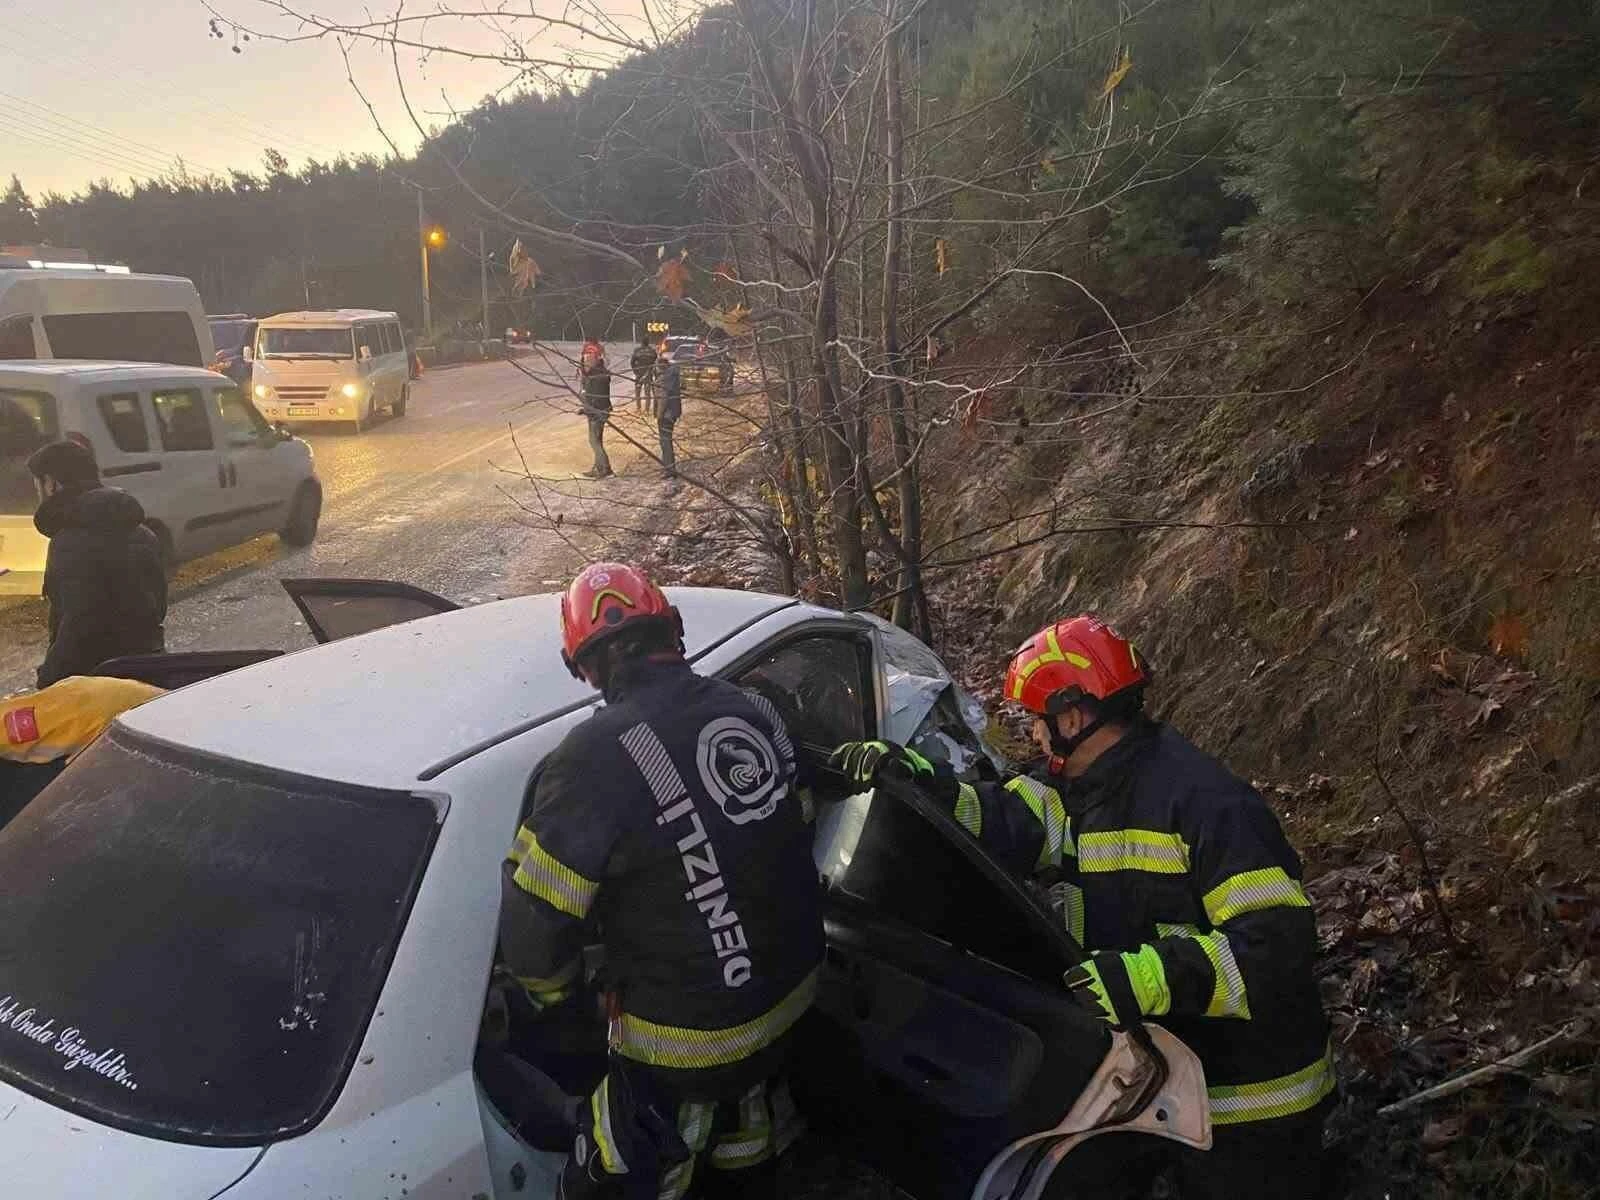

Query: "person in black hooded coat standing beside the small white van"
<box><xmin>27</xmin><ymin>442</ymin><xmax>166</xmax><ymax>688</ymax></box>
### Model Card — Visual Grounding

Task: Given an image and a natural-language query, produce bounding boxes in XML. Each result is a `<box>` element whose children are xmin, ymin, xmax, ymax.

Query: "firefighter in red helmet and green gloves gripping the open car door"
<box><xmin>835</xmin><ymin>616</ymin><xmax>1334</xmax><ymax>1200</ymax></box>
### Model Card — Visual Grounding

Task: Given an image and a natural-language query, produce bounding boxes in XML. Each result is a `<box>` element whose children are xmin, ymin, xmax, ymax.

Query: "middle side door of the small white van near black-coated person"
<box><xmin>150</xmin><ymin>382</ymin><xmax>232</xmax><ymax>558</ymax></box>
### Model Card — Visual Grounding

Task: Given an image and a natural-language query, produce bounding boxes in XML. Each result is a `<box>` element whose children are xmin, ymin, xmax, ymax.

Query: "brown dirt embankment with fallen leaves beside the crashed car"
<box><xmin>915</xmin><ymin>270</ymin><xmax>1600</xmax><ymax>1197</ymax></box>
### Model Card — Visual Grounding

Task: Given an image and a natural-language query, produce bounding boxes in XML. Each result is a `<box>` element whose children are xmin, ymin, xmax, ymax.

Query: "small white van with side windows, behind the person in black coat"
<box><xmin>0</xmin><ymin>362</ymin><xmax>322</xmax><ymax>595</ymax></box>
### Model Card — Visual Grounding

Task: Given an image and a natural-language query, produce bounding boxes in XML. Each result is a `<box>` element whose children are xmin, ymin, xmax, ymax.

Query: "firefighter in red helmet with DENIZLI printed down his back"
<box><xmin>501</xmin><ymin>563</ymin><xmax>822</xmax><ymax>1200</ymax></box>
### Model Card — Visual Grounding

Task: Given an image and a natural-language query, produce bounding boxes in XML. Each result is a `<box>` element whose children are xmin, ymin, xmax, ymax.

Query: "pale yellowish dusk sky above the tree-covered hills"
<box><xmin>0</xmin><ymin>0</ymin><xmax>662</xmax><ymax>198</ymax></box>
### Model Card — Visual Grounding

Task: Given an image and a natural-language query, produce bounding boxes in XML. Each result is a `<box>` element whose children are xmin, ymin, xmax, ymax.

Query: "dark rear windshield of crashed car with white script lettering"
<box><xmin>0</xmin><ymin>730</ymin><xmax>438</xmax><ymax>1146</ymax></box>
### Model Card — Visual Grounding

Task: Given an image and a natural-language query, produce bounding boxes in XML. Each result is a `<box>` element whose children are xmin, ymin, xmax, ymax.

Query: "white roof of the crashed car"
<box><xmin>122</xmin><ymin>587</ymin><xmax>798</xmax><ymax>787</ymax></box>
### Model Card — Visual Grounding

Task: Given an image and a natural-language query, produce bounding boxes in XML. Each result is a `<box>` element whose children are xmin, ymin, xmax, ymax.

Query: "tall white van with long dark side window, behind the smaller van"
<box><xmin>0</xmin><ymin>267</ymin><xmax>216</xmax><ymax>366</ymax></box>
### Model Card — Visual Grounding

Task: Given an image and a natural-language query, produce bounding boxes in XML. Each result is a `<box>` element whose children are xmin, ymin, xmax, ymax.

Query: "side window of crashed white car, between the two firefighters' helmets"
<box><xmin>734</xmin><ymin>634</ymin><xmax>877</xmax><ymax>750</ymax></box>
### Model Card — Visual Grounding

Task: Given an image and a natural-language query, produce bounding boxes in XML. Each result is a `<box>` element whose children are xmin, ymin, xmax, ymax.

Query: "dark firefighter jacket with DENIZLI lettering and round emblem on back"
<box><xmin>501</xmin><ymin>659</ymin><xmax>822</xmax><ymax>1099</ymax></box>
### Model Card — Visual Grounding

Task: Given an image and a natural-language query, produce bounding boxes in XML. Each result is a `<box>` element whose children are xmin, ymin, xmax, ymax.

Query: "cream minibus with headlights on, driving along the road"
<box><xmin>251</xmin><ymin>309</ymin><xmax>411</xmax><ymax>434</ymax></box>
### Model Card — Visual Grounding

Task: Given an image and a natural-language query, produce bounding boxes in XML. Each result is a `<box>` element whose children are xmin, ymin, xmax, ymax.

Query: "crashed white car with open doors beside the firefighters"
<box><xmin>0</xmin><ymin>581</ymin><xmax>1210</xmax><ymax>1200</ymax></box>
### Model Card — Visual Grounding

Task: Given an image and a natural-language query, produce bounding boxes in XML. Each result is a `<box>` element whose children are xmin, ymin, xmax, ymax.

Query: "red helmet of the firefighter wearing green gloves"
<box><xmin>1005</xmin><ymin>613</ymin><xmax>1150</xmax><ymax>717</ymax></box>
